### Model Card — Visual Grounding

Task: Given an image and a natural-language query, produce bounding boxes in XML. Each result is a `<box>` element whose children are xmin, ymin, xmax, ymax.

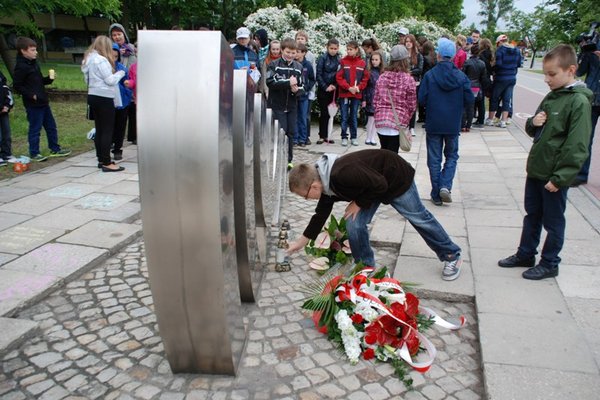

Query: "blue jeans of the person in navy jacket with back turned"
<box><xmin>425</xmin><ymin>133</ymin><xmax>458</xmax><ymax>200</ymax></box>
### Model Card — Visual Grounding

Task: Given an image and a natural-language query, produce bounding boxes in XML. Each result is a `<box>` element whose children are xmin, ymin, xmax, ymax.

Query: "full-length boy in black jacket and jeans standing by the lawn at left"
<box><xmin>14</xmin><ymin>37</ymin><xmax>71</xmax><ymax>161</ymax></box>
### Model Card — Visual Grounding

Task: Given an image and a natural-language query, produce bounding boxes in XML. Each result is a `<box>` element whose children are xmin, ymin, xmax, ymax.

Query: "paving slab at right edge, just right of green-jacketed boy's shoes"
<box><xmin>556</xmin><ymin>263</ymin><xmax>600</xmax><ymax>300</ymax></box>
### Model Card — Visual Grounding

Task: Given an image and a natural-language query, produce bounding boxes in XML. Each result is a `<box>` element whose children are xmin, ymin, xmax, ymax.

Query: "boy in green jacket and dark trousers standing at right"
<box><xmin>498</xmin><ymin>44</ymin><xmax>593</xmax><ymax>280</ymax></box>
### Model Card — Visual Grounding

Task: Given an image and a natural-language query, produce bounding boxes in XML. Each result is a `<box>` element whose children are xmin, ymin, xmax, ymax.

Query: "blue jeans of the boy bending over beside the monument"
<box><xmin>346</xmin><ymin>182</ymin><xmax>460</xmax><ymax>266</ymax></box>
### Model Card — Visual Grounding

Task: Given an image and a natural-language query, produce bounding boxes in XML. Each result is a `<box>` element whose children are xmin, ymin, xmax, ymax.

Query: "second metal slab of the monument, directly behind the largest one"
<box><xmin>233</xmin><ymin>70</ymin><xmax>262</xmax><ymax>302</ymax></box>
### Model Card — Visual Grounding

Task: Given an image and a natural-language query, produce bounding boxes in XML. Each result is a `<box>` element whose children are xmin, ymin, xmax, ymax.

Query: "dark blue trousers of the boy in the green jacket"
<box><xmin>517</xmin><ymin>178</ymin><xmax>568</xmax><ymax>268</ymax></box>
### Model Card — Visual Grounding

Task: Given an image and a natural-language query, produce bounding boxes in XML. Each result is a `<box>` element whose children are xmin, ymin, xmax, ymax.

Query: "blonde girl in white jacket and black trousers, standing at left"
<box><xmin>81</xmin><ymin>35</ymin><xmax>125</xmax><ymax>172</ymax></box>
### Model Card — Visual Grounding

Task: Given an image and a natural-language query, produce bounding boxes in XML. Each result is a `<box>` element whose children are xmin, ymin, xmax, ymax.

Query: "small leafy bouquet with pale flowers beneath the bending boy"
<box><xmin>304</xmin><ymin>215</ymin><xmax>352</xmax><ymax>271</ymax></box>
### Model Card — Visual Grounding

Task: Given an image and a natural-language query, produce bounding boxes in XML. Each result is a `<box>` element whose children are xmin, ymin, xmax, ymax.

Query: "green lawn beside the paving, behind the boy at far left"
<box><xmin>0</xmin><ymin>96</ymin><xmax>94</xmax><ymax>181</ymax></box>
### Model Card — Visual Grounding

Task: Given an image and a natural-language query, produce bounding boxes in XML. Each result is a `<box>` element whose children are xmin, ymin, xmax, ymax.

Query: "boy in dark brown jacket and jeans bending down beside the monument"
<box><xmin>288</xmin><ymin>149</ymin><xmax>462</xmax><ymax>281</ymax></box>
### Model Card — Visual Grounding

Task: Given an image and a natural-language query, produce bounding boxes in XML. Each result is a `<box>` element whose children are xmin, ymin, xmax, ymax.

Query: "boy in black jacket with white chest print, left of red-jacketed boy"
<box><xmin>267</xmin><ymin>38</ymin><xmax>305</xmax><ymax>171</ymax></box>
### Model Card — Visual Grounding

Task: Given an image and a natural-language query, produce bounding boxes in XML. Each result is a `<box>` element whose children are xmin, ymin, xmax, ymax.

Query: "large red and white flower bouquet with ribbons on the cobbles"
<box><xmin>302</xmin><ymin>265</ymin><xmax>466</xmax><ymax>387</ymax></box>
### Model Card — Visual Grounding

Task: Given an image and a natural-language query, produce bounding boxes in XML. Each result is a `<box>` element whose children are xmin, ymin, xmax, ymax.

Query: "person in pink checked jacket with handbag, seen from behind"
<box><xmin>373</xmin><ymin>45</ymin><xmax>417</xmax><ymax>153</ymax></box>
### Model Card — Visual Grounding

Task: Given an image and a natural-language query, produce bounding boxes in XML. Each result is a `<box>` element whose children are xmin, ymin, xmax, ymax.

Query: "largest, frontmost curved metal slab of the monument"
<box><xmin>137</xmin><ymin>30</ymin><xmax>246</xmax><ymax>374</ymax></box>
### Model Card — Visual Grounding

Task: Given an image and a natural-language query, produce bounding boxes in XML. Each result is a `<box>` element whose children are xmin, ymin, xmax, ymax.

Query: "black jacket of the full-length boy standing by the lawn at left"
<box><xmin>13</xmin><ymin>52</ymin><xmax>54</xmax><ymax>107</ymax></box>
